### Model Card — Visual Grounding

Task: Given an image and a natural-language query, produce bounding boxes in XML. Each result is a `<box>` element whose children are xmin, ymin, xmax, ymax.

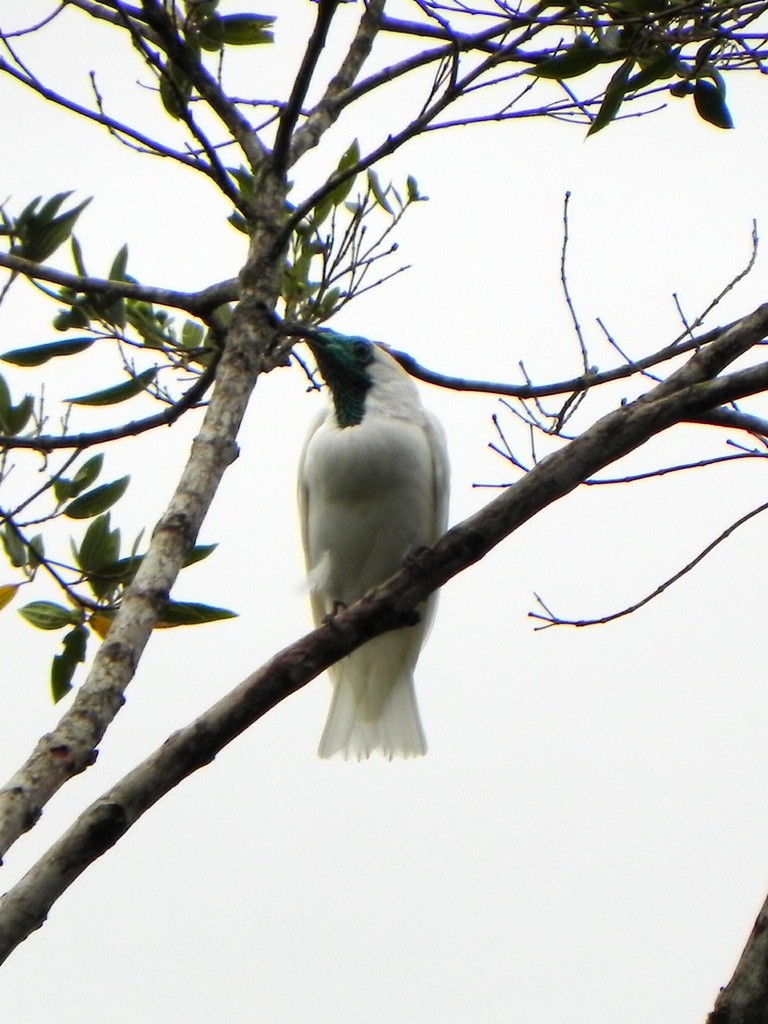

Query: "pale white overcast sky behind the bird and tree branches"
<box><xmin>0</xmin><ymin>0</ymin><xmax>768</xmax><ymax>1024</ymax></box>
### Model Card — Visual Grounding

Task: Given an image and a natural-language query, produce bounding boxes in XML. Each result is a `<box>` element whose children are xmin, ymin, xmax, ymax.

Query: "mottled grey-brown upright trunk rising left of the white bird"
<box><xmin>0</xmin><ymin>161</ymin><xmax>285</xmax><ymax>856</ymax></box>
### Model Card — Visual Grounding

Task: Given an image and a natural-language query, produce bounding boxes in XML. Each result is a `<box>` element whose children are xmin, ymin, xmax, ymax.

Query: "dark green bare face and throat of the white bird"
<box><xmin>305</xmin><ymin>328</ymin><xmax>378</xmax><ymax>427</ymax></box>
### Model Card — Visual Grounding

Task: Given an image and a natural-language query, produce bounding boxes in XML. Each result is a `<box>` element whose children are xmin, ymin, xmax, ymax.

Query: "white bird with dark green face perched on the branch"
<box><xmin>298</xmin><ymin>328</ymin><xmax>450</xmax><ymax>761</ymax></box>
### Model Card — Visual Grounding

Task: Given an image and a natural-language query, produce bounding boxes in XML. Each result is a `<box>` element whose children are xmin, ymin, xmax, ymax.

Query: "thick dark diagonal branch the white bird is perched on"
<box><xmin>0</xmin><ymin>305</ymin><xmax>768</xmax><ymax>959</ymax></box>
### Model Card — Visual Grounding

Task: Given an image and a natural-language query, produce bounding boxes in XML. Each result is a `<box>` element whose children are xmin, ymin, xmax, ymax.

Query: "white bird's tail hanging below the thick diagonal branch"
<box><xmin>317</xmin><ymin>628</ymin><xmax>427</xmax><ymax>761</ymax></box>
